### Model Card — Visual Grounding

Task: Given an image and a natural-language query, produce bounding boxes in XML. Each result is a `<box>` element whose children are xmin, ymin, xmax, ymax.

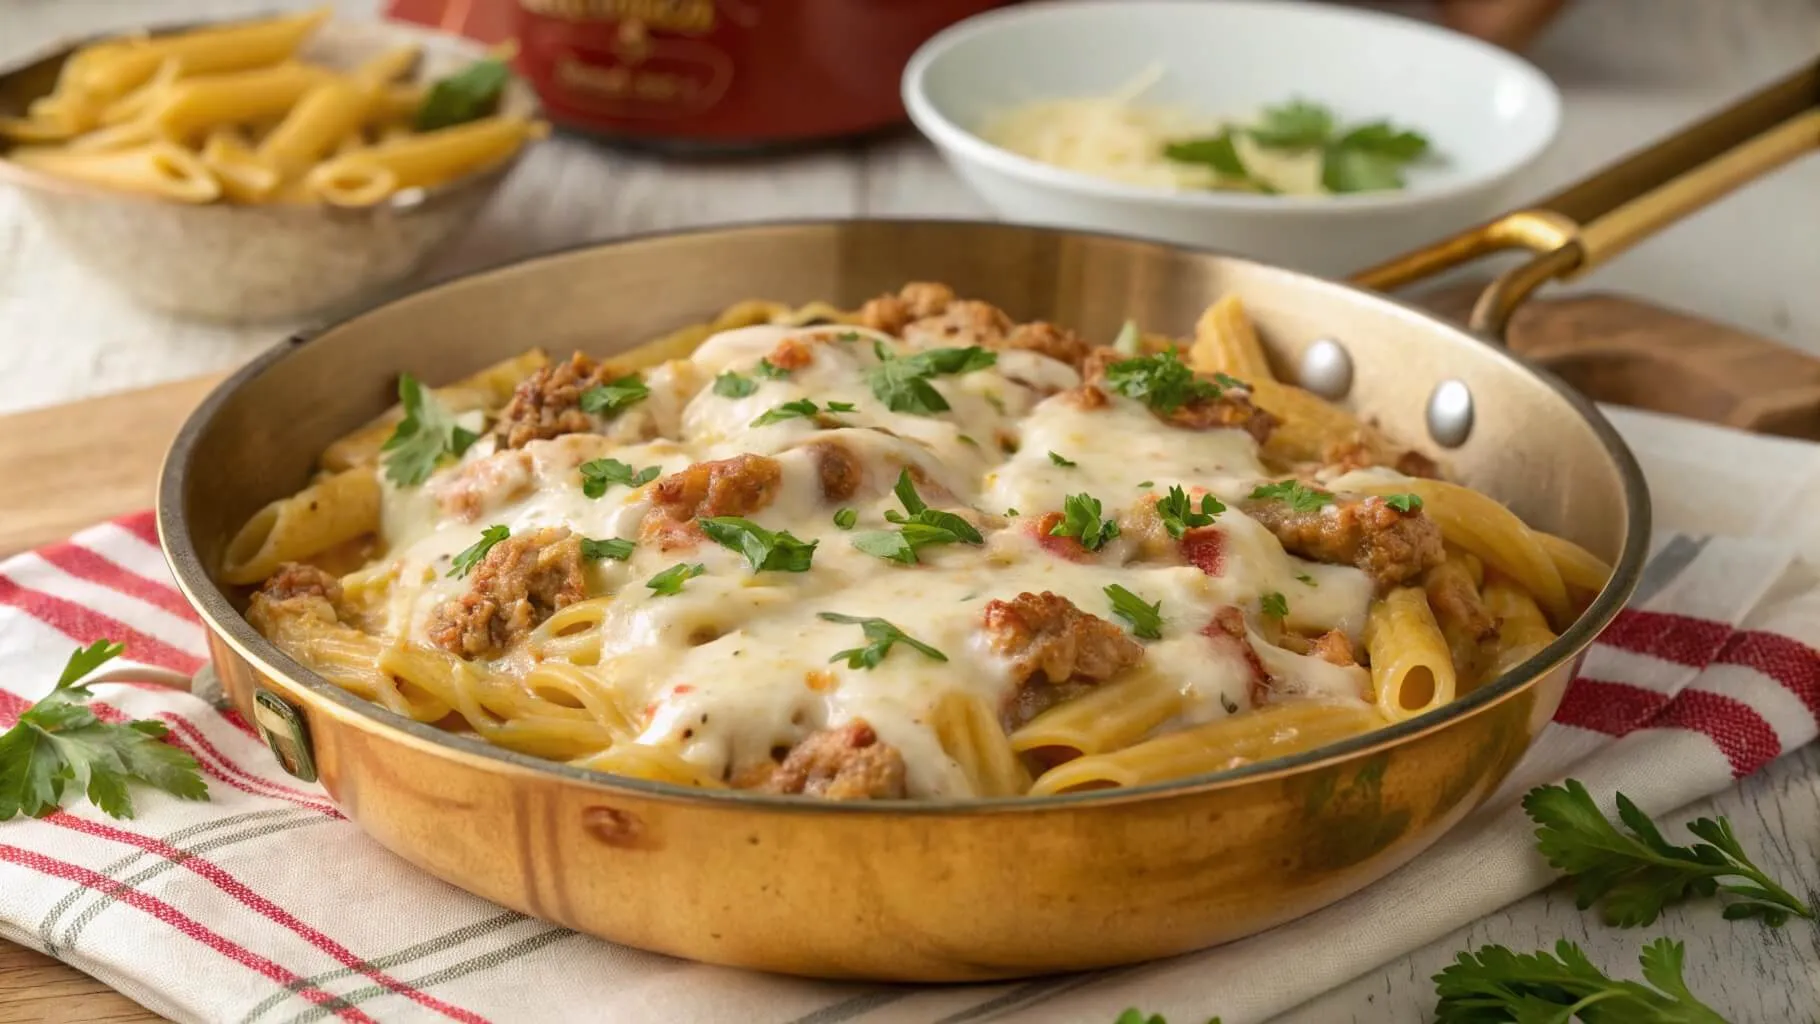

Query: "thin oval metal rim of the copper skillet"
<box><xmin>155</xmin><ymin>216</ymin><xmax>1651</xmax><ymax>817</ymax></box>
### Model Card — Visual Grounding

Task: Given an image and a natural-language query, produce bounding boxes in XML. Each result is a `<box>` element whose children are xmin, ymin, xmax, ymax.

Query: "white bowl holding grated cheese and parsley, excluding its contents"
<box><xmin>903</xmin><ymin>0</ymin><xmax>1562</xmax><ymax>276</ymax></box>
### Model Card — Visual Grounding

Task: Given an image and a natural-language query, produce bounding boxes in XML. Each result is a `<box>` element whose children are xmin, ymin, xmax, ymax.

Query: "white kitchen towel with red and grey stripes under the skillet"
<box><xmin>0</xmin><ymin>515</ymin><xmax>1820</xmax><ymax>1024</ymax></box>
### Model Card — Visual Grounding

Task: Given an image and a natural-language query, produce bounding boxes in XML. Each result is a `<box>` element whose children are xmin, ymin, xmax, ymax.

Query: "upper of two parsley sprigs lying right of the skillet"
<box><xmin>1523</xmin><ymin>778</ymin><xmax>1815</xmax><ymax>928</ymax></box>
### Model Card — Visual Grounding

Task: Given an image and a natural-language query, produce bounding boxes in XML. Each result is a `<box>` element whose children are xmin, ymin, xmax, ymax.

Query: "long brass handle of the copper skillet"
<box><xmin>1352</xmin><ymin>62</ymin><xmax>1820</xmax><ymax>342</ymax></box>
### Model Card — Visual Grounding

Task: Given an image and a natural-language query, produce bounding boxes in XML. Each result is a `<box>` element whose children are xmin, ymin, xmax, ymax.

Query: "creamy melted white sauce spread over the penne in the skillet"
<box><xmin>369</xmin><ymin>326</ymin><xmax>1372</xmax><ymax>797</ymax></box>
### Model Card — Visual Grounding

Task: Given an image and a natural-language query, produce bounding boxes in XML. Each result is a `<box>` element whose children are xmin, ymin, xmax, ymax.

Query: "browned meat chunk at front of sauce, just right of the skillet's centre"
<box><xmin>983</xmin><ymin>591</ymin><xmax>1143</xmax><ymax>729</ymax></box>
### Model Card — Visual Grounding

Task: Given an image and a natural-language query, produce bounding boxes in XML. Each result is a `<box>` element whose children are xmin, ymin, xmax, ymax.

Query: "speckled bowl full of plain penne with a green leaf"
<box><xmin>0</xmin><ymin>9</ymin><xmax>546</xmax><ymax>322</ymax></box>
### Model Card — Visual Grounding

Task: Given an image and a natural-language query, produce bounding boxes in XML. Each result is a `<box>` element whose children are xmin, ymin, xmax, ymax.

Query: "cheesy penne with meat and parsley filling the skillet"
<box><xmin>222</xmin><ymin>282</ymin><xmax>1609</xmax><ymax>800</ymax></box>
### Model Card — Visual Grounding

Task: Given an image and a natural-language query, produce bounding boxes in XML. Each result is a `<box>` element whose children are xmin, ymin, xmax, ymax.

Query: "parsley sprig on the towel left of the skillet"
<box><xmin>0</xmin><ymin>640</ymin><xmax>209</xmax><ymax>822</ymax></box>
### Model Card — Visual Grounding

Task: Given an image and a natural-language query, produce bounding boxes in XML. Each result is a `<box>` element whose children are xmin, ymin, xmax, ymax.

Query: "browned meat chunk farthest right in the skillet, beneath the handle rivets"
<box><xmin>1245</xmin><ymin>497</ymin><xmax>1443</xmax><ymax>587</ymax></box>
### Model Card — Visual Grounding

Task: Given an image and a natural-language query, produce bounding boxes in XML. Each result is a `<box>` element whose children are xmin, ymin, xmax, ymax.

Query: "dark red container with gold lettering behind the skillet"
<box><xmin>505</xmin><ymin>0</ymin><xmax>1006</xmax><ymax>149</ymax></box>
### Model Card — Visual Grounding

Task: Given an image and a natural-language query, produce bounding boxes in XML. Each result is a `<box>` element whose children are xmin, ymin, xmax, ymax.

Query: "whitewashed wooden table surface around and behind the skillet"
<box><xmin>0</xmin><ymin>0</ymin><xmax>1820</xmax><ymax>1024</ymax></box>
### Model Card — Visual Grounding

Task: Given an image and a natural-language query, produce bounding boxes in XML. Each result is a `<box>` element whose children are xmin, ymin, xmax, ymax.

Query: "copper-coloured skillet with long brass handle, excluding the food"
<box><xmin>158</xmin><ymin>67</ymin><xmax>1820</xmax><ymax>980</ymax></box>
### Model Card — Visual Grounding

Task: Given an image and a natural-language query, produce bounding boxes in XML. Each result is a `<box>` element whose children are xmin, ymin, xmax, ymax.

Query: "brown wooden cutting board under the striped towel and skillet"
<box><xmin>0</xmin><ymin>289</ymin><xmax>1820</xmax><ymax>1024</ymax></box>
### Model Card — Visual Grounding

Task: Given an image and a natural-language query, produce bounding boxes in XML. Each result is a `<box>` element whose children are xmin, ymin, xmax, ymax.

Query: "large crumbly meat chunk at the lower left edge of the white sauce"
<box><xmin>430</xmin><ymin>526</ymin><xmax>588</xmax><ymax>658</ymax></box>
